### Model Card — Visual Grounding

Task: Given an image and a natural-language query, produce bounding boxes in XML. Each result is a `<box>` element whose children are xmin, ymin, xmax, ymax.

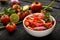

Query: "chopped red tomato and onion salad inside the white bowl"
<box><xmin>24</xmin><ymin>13</ymin><xmax>53</xmax><ymax>31</ymax></box>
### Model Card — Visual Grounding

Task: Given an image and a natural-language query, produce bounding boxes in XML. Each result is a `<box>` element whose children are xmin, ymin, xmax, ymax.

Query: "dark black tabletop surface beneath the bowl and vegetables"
<box><xmin>0</xmin><ymin>0</ymin><xmax>60</xmax><ymax>40</ymax></box>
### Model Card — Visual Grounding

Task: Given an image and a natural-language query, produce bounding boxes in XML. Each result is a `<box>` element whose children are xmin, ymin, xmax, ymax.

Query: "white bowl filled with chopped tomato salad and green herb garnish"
<box><xmin>23</xmin><ymin>13</ymin><xmax>56</xmax><ymax>37</ymax></box>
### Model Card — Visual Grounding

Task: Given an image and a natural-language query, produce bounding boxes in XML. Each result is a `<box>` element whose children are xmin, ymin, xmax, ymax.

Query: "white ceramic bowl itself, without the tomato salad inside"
<box><xmin>23</xmin><ymin>13</ymin><xmax>56</xmax><ymax>37</ymax></box>
